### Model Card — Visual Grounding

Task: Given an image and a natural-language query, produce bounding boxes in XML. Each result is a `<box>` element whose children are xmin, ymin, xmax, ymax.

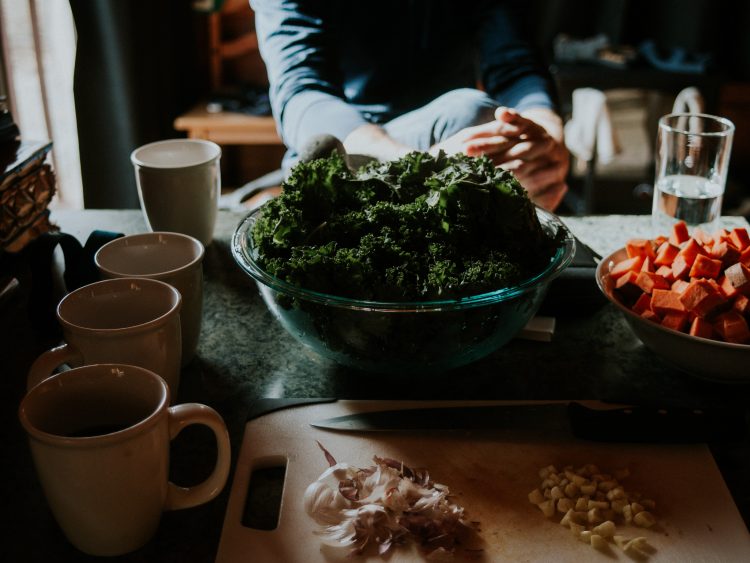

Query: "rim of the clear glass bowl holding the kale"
<box><xmin>231</xmin><ymin>204</ymin><xmax>575</xmax><ymax>312</ymax></box>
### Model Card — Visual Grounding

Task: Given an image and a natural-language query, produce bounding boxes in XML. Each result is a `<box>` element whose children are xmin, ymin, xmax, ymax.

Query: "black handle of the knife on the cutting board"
<box><xmin>568</xmin><ymin>403</ymin><xmax>747</xmax><ymax>443</ymax></box>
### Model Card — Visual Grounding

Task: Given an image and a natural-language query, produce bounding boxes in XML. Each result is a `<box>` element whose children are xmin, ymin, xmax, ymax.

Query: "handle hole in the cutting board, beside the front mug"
<box><xmin>242</xmin><ymin>457</ymin><xmax>286</xmax><ymax>531</ymax></box>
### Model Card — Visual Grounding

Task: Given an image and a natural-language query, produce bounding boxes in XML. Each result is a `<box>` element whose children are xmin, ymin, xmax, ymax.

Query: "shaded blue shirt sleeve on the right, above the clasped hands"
<box><xmin>479</xmin><ymin>0</ymin><xmax>555</xmax><ymax>111</ymax></box>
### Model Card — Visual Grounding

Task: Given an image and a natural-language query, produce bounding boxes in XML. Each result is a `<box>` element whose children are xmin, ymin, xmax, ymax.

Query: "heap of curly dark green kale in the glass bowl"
<box><xmin>250</xmin><ymin>152</ymin><xmax>559</xmax><ymax>301</ymax></box>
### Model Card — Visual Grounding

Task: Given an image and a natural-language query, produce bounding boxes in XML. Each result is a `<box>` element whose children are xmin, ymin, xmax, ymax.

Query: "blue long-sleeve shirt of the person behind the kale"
<box><xmin>250</xmin><ymin>0</ymin><xmax>553</xmax><ymax>150</ymax></box>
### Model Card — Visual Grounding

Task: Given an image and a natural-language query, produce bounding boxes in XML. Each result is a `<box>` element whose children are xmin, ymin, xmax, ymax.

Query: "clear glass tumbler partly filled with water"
<box><xmin>652</xmin><ymin>113</ymin><xmax>734</xmax><ymax>235</ymax></box>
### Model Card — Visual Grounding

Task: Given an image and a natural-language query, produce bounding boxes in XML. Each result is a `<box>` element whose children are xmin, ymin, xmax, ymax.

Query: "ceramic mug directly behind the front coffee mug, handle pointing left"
<box><xmin>27</xmin><ymin>278</ymin><xmax>182</xmax><ymax>397</ymax></box>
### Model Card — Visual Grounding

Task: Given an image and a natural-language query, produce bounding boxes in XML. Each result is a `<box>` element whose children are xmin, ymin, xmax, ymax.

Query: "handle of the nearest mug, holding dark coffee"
<box><xmin>164</xmin><ymin>403</ymin><xmax>231</xmax><ymax>510</ymax></box>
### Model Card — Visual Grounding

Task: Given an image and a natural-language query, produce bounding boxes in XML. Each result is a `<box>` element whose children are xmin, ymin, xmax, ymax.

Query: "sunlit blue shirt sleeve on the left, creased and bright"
<box><xmin>250</xmin><ymin>0</ymin><xmax>367</xmax><ymax>152</ymax></box>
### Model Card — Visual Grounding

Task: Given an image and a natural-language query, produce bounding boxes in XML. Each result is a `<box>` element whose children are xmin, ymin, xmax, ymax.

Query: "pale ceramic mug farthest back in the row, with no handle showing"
<box><xmin>130</xmin><ymin>139</ymin><xmax>221</xmax><ymax>246</ymax></box>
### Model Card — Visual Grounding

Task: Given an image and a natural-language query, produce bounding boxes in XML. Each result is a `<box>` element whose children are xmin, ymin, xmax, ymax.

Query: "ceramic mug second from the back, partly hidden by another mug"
<box><xmin>94</xmin><ymin>232</ymin><xmax>205</xmax><ymax>366</ymax></box>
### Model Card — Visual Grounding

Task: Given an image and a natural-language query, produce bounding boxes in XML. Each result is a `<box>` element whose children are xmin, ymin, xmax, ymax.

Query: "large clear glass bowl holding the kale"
<box><xmin>232</xmin><ymin>206</ymin><xmax>575</xmax><ymax>373</ymax></box>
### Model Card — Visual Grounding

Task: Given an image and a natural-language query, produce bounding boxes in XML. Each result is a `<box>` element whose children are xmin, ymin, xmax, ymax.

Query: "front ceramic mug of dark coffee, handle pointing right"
<box><xmin>19</xmin><ymin>364</ymin><xmax>230</xmax><ymax>556</ymax></box>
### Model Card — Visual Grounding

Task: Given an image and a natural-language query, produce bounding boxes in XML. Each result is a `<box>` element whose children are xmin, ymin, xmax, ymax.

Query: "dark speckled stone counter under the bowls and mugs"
<box><xmin>2</xmin><ymin>211</ymin><xmax>750</xmax><ymax>562</ymax></box>
